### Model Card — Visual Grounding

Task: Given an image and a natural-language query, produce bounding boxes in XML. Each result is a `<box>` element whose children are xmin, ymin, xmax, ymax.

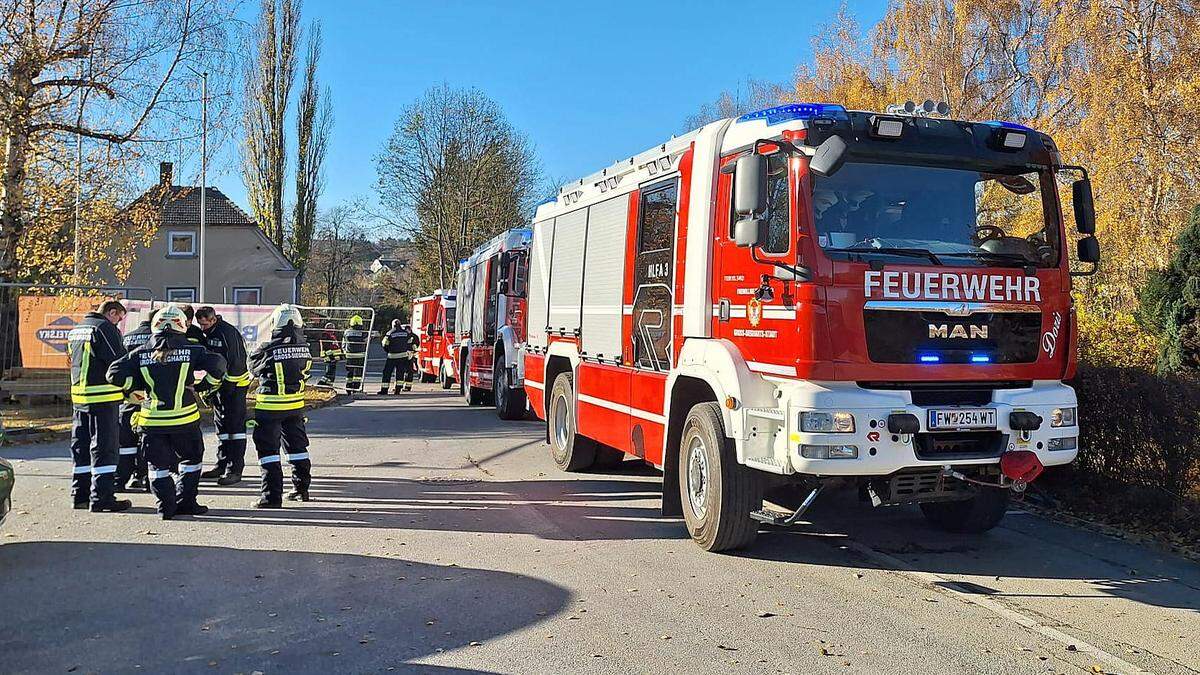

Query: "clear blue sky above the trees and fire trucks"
<box><xmin>201</xmin><ymin>0</ymin><xmax>884</xmax><ymax>223</ymax></box>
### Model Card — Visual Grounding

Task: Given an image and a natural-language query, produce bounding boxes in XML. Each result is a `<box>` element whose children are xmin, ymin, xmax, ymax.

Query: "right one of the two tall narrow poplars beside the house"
<box><xmin>288</xmin><ymin>22</ymin><xmax>334</xmax><ymax>296</ymax></box>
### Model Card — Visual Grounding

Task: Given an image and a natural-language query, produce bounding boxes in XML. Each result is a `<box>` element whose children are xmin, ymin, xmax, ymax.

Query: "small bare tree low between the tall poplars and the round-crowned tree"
<box><xmin>308</xmin><ymin>202</ymin><xmax>373</xmax><ymax>305</ymax></box>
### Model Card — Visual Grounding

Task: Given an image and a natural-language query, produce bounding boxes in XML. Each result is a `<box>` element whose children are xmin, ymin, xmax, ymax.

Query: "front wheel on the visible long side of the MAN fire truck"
<box><xmin>678</xmin><ymin>404</ymin><xmax>762</xmax><ymax>551</ymax></box>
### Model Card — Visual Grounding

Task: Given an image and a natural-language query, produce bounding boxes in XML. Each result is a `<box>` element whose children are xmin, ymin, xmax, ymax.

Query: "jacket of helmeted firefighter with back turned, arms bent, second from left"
<box><xmin>108</xmin><ymin>331</ymin><xmax>226</xmax><ymax>430</ymax></box>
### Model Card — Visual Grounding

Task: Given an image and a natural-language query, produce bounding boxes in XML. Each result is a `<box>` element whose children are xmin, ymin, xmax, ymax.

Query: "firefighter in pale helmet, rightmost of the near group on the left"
<box><xmin>250</xmin><ymin>305</ymin><xmax>312</xmax><ymax>508</ymax></box>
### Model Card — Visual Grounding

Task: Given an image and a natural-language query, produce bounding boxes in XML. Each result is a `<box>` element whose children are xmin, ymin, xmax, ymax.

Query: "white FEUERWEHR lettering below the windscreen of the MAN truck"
<box><xmin>863</xmin><ymin>270</ymin><xmax>1042</xmax><ymax>303</ymax></box>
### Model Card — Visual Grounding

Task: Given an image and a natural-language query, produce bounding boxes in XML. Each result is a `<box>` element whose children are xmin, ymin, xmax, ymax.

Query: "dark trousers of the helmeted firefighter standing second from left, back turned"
<box><xmin>143</xmin><ymin>423</ymin><xmax>204</xmax><ymax>515</ymax></box>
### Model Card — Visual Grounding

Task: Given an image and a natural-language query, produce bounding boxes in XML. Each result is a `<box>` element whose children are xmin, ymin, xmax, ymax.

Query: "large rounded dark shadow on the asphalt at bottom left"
<box><xmin>0</xmin><ymin>542</ymin><xmax>570</xmax><ymax>673</ymax></box>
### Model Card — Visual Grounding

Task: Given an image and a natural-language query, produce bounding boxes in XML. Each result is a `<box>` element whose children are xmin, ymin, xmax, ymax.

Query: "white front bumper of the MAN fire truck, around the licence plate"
<box><xmin>776</xmin><ymin>381</ymin><xmax>1079</xmax><ymax>476</ymax></box>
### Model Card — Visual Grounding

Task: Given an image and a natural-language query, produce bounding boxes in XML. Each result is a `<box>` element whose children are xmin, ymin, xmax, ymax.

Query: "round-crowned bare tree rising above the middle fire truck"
<box><xmin>376</xmin><ymin>84</ymin><xmax>540</xmax><ymax>288</ymax></box>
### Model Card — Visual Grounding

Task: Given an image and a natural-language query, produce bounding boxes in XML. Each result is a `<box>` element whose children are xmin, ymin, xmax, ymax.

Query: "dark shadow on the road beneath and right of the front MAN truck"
<box><xmin>737</xmin><ymin>480</ymin><xmax>1200</xmax><ymax>611</ymax></box>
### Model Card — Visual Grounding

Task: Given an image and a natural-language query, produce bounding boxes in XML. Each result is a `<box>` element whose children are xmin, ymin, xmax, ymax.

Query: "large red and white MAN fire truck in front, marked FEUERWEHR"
<box><xmin>524</xmin><ymin>102</ymin><xmax>1099</xmax><ymax>550</ymax></box>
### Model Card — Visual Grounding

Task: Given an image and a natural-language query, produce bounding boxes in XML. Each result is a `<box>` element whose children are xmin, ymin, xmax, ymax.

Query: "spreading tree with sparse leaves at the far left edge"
<box><xmin>0</xmin><ymin>0</ymin><xmax>232</xmax><ymax>280</ymax></box>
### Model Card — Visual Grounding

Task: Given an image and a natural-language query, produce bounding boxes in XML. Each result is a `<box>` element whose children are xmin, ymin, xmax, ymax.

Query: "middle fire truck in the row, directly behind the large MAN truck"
<box><xmin>457</xmin><ymin>228</ymin><xmax>532</xmax><ymax>419</ymax></box>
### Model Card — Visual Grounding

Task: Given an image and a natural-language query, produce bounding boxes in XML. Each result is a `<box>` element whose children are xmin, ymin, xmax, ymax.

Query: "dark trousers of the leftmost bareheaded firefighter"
<box><xmin>71</xmin><ymin>401</ymin><xmax>120</xmax><ymax>504</ymax></box>
